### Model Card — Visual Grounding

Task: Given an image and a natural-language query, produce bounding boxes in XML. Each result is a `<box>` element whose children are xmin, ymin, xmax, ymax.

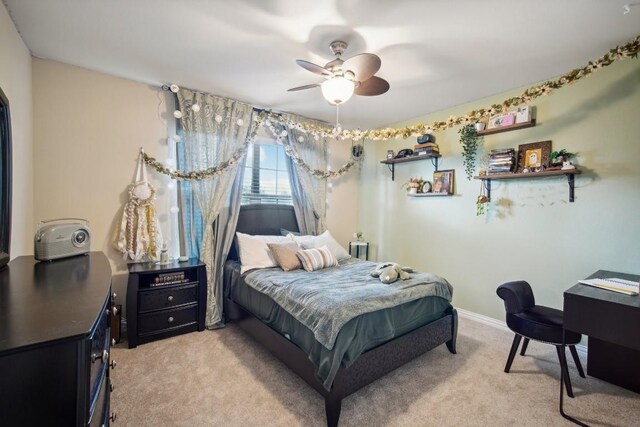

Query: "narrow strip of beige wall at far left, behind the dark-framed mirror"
<box><xmin>0</xmin><ymin>4</ymin><xmax>34</xmax><ymax>258</ymax></box>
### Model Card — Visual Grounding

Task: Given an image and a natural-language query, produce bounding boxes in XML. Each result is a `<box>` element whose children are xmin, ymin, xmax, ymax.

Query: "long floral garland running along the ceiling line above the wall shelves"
<box><xmin>259</xmin><ymin>35</ymin><xmax>640</xmax><ymax>141</ymax></box>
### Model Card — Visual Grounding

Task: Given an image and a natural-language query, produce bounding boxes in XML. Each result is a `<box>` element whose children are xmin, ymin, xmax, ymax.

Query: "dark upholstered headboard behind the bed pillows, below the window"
<box><xmin>228</xmin><ymin>204</ymin><xmax>300</xmax><ymax>259</ymax></box>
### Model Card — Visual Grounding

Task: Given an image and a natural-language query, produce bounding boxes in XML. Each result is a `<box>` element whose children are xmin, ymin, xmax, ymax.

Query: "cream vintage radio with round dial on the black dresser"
<box><xmin>33</xmin><ymin>218</ymin><xmax>91</xmax><ymax>261</ymax></box>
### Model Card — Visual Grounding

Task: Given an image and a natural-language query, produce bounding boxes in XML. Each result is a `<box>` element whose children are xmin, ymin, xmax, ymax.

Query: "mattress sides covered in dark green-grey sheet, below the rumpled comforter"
<box><xmin>224</xmin><ymin>261</ymin><xmax>452</xmax><ymax>390</ymax></box>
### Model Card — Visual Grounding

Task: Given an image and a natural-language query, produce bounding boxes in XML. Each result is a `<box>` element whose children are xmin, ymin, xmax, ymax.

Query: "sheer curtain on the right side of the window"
<box><xmin>281</xmin><ymin>114</ymin><xmax>327</xmax><ymax>235</ymax></box>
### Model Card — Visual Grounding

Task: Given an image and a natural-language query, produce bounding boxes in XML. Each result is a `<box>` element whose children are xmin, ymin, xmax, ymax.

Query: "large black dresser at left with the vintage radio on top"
<box><xmin>0</xmin><ymin>252</ymin><xmax>115</xmax><ymax>426</ymax></box>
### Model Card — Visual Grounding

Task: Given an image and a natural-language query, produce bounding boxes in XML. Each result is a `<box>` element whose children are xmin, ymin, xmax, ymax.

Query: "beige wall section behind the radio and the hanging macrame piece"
<box><xmin>33</xmin><ymin>59</ymin><xmax>173</xmax><ymax>295</ymax></box>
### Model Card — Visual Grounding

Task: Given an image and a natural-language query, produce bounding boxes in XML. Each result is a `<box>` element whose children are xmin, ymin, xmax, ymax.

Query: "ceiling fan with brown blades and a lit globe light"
<box><xmin>288</xmin><ymin>40</ymin><xmax>389</xmax><ymax>105</ymax></box>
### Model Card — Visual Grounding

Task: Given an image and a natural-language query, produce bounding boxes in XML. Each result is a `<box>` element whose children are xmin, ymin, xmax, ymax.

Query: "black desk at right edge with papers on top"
<box><xmin>560</xmin><ymin>270</ymin><xmax>640</xmax><ymax>425</ymax></box>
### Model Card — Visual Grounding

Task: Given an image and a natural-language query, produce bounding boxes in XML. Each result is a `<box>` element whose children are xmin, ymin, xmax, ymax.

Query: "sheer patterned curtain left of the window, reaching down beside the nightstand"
<box><xmin>177</xmin><ymin>89</ymin><xmax>253</xmax><ymax>328</ymax></box>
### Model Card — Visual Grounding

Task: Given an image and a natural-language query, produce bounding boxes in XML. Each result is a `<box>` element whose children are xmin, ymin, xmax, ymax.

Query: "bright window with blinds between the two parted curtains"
<box><xmin>242</xmin><ymin>139</ymin><xmax>293</xmax><ymax>205</ymax></box>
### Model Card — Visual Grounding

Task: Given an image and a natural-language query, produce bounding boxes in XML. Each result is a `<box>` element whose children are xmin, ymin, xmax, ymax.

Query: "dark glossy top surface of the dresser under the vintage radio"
<box><xmin>0</xmin><ymin>252</ymin><xmax>111</xmax><ymax>354</ymax></box>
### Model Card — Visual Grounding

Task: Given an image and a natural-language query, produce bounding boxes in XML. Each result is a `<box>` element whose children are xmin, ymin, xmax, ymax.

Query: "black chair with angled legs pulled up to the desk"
<box><xmin>496</xmin><ymin>280</ymin><xmax>584</xmax><ymax>397</ymax></box>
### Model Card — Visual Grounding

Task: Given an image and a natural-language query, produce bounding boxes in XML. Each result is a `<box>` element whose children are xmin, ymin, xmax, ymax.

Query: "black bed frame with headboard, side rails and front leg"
<box><xmin>224</xmin><ymin>205</ymin><xmax>458</xmax><ymax>427</ymax></box>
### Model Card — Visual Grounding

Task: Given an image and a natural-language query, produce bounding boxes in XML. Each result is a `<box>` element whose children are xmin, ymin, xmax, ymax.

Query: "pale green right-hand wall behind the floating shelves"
<box><xmin>359</xmin><ymin>59</ymin><xmax>640</xmax><ymax>319</ymax></box>
